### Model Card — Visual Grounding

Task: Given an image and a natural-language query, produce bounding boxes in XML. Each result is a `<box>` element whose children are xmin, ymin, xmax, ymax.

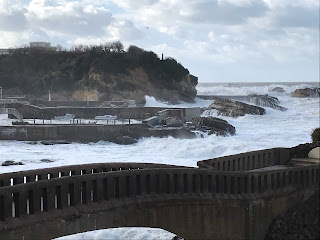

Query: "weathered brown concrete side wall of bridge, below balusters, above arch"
<box><xmin>1</xmin><ymin>190</ymin><xmax>314</xmax><ymax>240</ymax></box>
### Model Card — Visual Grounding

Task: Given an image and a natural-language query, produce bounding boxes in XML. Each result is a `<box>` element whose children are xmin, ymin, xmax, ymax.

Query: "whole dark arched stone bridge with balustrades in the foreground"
<box><xmin>0</xmin><ymin>148</ymin><xmax>319</xmax><ymax>240</ymax></box>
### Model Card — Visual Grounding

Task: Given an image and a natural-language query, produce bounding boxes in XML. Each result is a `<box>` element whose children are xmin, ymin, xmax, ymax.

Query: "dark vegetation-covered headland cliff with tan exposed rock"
<box><xmin>0</xmin><ymin>47</ymin><xmax>198</xmax><ymax>102</ymax></box>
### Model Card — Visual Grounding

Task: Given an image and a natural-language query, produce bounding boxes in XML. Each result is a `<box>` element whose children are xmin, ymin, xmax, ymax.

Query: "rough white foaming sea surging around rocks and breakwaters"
<box><xmin>0</xmin><ymin>82</ymin><xmax>320</xmax><ymax>240</ymax></box>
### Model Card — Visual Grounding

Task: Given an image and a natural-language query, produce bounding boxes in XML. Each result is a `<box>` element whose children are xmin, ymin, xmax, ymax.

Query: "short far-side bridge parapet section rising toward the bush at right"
<box><xmin>197</xmin><ymin>148</ymin><xmax>290</xmax><ymax>171</ymax></box>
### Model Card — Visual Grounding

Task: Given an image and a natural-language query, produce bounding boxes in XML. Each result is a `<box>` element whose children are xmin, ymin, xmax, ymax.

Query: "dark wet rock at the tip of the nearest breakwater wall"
<box><xmin>192</xmin><ymin>117</ymin><xmax>236</xmax><ymax>136</ymax></box>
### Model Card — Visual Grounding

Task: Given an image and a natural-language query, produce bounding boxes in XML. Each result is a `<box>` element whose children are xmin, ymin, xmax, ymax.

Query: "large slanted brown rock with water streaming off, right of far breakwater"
<box><xmin>206</xmin><ymin>97</ymin><xmax>265</xmax><ymax>117</ymax></box>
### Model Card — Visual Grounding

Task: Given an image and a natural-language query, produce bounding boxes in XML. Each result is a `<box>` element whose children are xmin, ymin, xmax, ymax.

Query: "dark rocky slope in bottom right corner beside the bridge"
<box><xmin>265</xmin><ymin>191</ymin><xmax>320</xmax><ymax>240</ymax></box>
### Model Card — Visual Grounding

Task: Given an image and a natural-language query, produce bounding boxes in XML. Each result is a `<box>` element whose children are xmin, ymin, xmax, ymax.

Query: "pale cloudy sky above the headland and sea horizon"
<box><xmin>0</xmin><ymin>0</ymin><xmax>320</xmax><ymax>82</ymax></box>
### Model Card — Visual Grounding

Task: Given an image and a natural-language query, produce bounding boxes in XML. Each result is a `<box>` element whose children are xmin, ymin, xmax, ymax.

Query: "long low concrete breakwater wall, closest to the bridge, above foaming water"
<box><xmin>0</xmin><ymin>124</ymin><xmax>195</xmax><ymax>142</ymax></box>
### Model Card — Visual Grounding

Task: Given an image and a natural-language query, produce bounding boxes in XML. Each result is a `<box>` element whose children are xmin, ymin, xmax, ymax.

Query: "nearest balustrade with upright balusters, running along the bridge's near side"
<box><xmin>0</xmin><ymin>165</ymin><xmax>319</xmax><ymax>223</ymax></box>
